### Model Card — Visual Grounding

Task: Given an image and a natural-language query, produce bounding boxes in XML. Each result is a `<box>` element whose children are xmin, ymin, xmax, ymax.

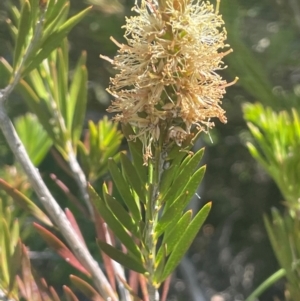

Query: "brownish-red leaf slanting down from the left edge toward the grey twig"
<box><xmin>0</xmin><ymin>178</ymin><xmax>53</xmax><ymax>227</ymax></box>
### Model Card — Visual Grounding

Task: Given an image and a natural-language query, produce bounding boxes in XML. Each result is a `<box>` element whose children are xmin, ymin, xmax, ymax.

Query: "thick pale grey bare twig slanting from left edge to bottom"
<box><xmin>0</xmin><ymin>5</ymin><xmax>118</xmax><ymax>301</ymax></box>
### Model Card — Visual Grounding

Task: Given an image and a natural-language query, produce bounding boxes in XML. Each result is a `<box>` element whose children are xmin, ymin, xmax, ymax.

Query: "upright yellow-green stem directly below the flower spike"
<box><xmin>145</xmin><ymin>146</ymin><xmax>163</xmax><ymax>301</ymax></box>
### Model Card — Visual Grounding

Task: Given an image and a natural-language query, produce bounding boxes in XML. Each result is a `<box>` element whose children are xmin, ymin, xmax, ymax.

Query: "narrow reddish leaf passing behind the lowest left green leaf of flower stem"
<box><xmin>94</xmin><ymin>210</ymin><xmax>116</xmax><ymax>291</ymax></box>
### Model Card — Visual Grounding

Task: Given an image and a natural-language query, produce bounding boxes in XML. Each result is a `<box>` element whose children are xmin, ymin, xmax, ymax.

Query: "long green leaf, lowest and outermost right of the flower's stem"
<box><xmin>159</xmin><ymin>203</ymin><xmax>211</xmax><ymax>283</ymax></box>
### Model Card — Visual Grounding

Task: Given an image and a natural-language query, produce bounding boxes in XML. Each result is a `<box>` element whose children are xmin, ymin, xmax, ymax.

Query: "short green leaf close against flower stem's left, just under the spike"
<box><xmin>120</xmin><ymin>152</ymin><xmax>146</xmax><ymax>203</ymax></box>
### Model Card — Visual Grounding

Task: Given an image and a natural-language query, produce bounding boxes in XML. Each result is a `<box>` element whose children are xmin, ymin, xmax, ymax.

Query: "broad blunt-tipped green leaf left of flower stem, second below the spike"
<box><xmin>108</xmin><ymin>159</ymin><xmax>142</xmax><ymax>223</ymax></box>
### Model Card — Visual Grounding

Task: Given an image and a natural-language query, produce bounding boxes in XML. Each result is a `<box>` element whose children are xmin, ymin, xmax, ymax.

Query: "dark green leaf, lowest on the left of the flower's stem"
<box><xmin>97</xmin><ymin>240</ymin><xmax>147</xmax><ymax>274</ymax></box>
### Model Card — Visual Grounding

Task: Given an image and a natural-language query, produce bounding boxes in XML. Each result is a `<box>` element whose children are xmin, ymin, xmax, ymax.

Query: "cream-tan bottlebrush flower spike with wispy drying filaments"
<box><xmin>102</xmin><ymin>0</ymin><xmax>235</xmax><ymax>164</ymax></box>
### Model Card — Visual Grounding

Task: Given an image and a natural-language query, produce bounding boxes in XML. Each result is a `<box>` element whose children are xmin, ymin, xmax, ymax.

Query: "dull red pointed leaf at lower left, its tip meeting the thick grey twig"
<box><xmin>33</xmin><ymin>223</ymin><xmax>90</xmax><ymax>276</ymax></box>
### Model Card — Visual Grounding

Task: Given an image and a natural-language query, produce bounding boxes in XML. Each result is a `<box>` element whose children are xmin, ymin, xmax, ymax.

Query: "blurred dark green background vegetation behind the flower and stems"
<box><xmin>0</xmin><ymin>0</ymin><xmax>300</xmax><ymax>301</ymax></box>
